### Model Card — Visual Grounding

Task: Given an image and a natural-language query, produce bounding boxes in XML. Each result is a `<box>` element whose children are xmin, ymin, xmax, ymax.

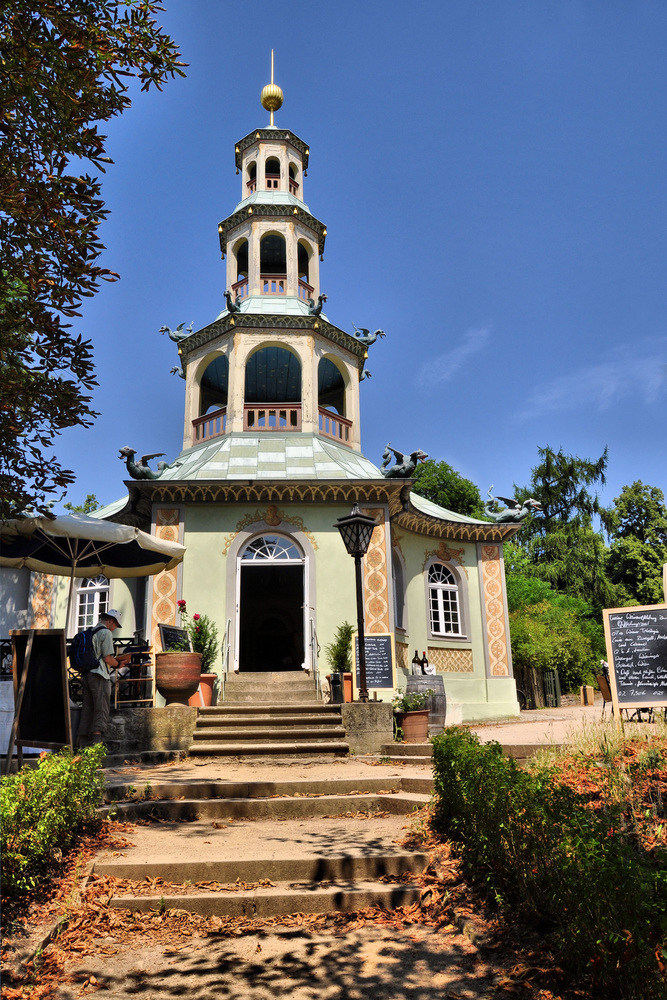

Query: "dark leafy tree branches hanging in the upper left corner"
<box><xmin>0</xmin><ymin>0</ymin><xmax>185</xmax><ymax>515</ymax></box>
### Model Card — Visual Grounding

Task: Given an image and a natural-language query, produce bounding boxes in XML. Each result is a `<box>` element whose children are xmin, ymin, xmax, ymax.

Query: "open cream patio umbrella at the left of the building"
<box><xmin>0</xmin><ymin>514</ymin><xmax>185</xmax><ymax>622</ymax></box>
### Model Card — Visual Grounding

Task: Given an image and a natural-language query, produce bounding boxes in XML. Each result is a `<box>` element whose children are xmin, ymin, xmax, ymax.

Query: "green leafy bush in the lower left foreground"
<box><xmin>0</xmin><ymin>743</ymin><xmax>106</xmax><ymax>896</ymax></box>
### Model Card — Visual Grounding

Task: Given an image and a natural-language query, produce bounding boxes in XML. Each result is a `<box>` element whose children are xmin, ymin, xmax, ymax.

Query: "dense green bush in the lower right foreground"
<box><xmin>433</xmin><ymin>729</ymin><xmax>667</xmax><ymax>1000</ymax></box>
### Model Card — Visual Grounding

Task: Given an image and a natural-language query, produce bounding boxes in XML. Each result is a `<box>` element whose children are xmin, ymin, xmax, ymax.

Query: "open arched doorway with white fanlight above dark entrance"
<box><xmin>236</xmin><ymin>532</ymin><xmax>307</xmax><ymax>671</ymax></box>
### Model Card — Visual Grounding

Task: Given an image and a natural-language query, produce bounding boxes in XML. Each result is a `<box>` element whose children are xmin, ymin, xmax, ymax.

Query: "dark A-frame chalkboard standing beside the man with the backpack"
<box><xmin>6</xmin><ymin>629</ymin><xmax>72</xmax><ymax>773</ymax></box>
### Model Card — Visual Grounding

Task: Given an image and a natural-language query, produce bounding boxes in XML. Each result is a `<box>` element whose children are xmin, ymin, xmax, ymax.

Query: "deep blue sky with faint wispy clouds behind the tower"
<box><xmin>55</xmin><ymin>0</ymin><xmax>667</xmax><ymax>502</ymax></box>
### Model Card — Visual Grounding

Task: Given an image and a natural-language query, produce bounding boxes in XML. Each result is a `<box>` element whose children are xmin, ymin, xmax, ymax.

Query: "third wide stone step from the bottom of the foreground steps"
<box><xmin>104</xmin><ymin>791</ymin><xmax>430</xmax><ymax>823</ymax></box>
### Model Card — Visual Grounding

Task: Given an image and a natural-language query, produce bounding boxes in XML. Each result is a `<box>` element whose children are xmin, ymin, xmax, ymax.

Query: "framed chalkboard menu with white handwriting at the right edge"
<box><xmin>604</xmin><ymin>604</ymin><xmax>667</xmax><ymax>712</ymax></box>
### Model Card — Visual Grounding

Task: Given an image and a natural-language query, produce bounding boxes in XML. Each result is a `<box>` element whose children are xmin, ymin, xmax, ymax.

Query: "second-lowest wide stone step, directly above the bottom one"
<box><xmin>93</xmin><ymin>848</ymin><xmax>429</xmax><ymax>884</ymax></box>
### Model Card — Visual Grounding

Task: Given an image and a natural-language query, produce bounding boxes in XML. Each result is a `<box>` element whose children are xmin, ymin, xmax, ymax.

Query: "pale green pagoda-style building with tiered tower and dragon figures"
<box><xmin>58</xmin><ymin>72</ymin><xmax>518</xmax><ymax>722</ymax></box>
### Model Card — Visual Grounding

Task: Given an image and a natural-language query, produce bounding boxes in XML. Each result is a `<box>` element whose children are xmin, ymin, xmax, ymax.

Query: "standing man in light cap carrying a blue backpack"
<box><xmin>77</xmin><ymin>608</ymin><xmax>132</xmax><ymax>747</ymax></box>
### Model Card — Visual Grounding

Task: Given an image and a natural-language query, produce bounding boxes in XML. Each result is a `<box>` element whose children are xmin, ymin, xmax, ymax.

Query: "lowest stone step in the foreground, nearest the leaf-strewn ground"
<box><xmin>109</xmin><ymin>882</ymin><xmax>421</xmax><ymax>917</ymax></box>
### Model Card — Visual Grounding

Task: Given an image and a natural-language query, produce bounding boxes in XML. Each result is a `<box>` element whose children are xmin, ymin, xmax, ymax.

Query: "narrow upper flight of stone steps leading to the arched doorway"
<box><xmin>189</xmin><ymin>670</ymin><xmax>350</xmax><ymax>757</ymax></box>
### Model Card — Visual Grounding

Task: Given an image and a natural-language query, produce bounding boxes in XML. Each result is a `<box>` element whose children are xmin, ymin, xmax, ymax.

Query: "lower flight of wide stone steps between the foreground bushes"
<box><xmin>99</xmin><ymin>775</ymin><xmax>432</xmax><ymax>917</ymax></box>
